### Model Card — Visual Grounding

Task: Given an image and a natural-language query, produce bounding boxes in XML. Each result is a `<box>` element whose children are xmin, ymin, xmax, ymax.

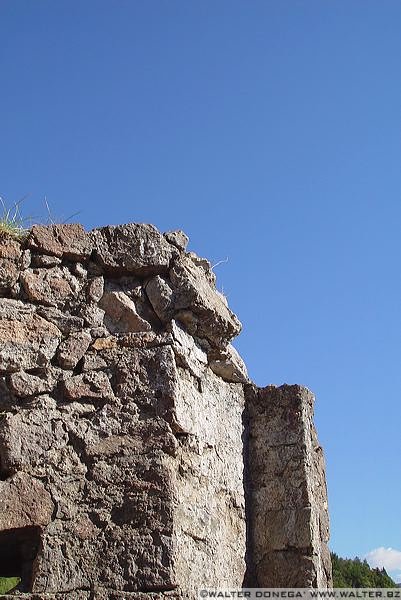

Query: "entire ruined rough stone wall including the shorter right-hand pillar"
<box><xmin>0</xmin><ymin>224</ymin><xmax>330</xmax><ymax>600</ymax></box>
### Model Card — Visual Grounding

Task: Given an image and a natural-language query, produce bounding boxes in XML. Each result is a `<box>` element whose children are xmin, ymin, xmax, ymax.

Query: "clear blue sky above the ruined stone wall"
<box><xmin>0</xmin><ymin>0</ymin><xmax>401</xmax><ymax>576</ymax></box>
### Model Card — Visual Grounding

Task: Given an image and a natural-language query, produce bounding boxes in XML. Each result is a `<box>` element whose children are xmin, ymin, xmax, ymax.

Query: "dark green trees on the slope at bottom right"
<box><xmin>331</xmin><ymin>552</ymin><xmax>397</xmax><ymax>588</ymax></box>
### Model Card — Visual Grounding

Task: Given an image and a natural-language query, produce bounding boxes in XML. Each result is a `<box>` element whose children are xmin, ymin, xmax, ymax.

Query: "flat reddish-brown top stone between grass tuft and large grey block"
<box><xmin>28</xmin><ymin>223</ymin><xmax>92</xmax><ymax>260</ymax></box>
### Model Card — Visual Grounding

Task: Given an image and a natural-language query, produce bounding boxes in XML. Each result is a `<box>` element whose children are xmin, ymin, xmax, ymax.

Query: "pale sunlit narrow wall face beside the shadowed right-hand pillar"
<box><xmin>174</xmin><ymin>369</ymin><xmax>245</xmax><ymax>597</ymax></box>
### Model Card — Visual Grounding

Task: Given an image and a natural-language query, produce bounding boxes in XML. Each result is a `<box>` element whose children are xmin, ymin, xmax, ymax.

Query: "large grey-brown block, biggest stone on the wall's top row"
<box><xmin>91</xmin><ymin>223</ymin><xmax>177</xmax><ymax>276</ymax></box>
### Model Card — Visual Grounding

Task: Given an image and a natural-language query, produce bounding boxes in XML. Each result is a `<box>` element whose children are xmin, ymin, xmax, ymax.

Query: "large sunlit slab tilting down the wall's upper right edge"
<box><xmin>170</xmin><ymin>257</ymin><xmax>241</xmax><ymax>347</ymax></box>
